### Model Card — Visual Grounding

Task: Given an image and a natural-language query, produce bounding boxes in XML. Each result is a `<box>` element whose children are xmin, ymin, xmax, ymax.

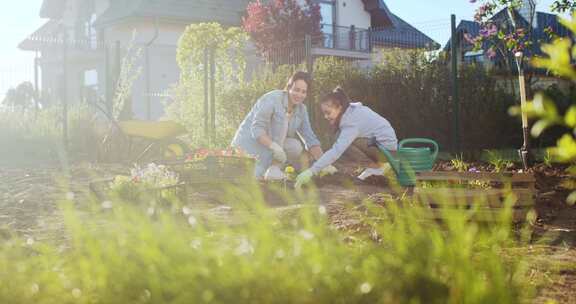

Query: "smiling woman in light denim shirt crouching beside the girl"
<box><xmin>232</xmin><ymin>72</ymin><xmax>332</xmax><ymax>179</ymax></box>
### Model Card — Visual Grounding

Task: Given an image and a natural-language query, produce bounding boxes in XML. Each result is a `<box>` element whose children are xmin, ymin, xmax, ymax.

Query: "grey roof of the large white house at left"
<box><xmin>95</xmin><ymin>0</ymin><xmax>249</xmax><ymax>26</ymax></box>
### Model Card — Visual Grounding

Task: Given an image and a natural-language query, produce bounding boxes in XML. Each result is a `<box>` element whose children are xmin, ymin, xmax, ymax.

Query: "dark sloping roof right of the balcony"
<box><xmin>372</xmin><ymin>13</ymin><xmax>440</xmax><ymax>49</ymax></box>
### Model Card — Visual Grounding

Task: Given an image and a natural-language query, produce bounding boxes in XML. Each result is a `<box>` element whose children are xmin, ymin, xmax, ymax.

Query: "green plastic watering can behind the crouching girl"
<box><xmin>378</xmin><ymin>138</ymin><xmax>438</xmax><ymax>187</ymax></box>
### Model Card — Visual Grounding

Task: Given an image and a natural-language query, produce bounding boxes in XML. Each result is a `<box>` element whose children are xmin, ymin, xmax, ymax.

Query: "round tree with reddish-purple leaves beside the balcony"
<box><xmin>242</xmin><ymin>0</ymin><xmax>322</xmax><ymax>61</ymax></box>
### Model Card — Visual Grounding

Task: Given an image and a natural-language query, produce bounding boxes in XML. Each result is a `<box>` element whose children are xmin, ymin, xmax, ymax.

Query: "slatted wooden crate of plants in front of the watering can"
<box><xmin>413</xmin><ymin>172</ymin><xmax>536</xmax><ymax>222</ymax></box>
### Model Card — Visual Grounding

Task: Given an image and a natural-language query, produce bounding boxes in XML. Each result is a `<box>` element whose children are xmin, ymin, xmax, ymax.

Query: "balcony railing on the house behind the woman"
<box><xmin>314</xmin><ymin>24</ymin><xmax>371</xmax><ymax>53</ymax></box>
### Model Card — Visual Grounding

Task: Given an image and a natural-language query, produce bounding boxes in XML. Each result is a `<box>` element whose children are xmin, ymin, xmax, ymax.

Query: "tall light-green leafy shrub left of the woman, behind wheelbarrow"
<box><xmin>165</xmin><ymin>23</ymin><xmax>248</xmax><ymax>147</ymax></box>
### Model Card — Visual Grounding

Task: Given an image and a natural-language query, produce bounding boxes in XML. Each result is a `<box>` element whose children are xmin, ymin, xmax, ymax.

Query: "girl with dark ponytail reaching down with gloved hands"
<box><xmin>296</xmin><ymin>87</ymin><xmax>398</xmax><ymax>187</ymax></box>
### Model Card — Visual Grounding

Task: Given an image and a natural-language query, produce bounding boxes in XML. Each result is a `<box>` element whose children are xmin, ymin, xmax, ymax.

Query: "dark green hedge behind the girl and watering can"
<box><xmin>314</xmin><ymin>50</ymin><xmax>520</xmax><ymax>150</ymax></box>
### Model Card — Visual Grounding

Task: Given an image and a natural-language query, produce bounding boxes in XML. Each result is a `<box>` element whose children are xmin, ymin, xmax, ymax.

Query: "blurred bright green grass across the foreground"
<box><xmin>0</xmin><ymin>182</ymin><xmax>532</xmax><ymax>304</ymax></box>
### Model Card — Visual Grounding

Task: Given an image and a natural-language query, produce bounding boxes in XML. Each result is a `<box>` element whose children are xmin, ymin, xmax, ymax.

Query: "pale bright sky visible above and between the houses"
<box><xmin>0</xmin><ymin>0</ymin><xmax>568</xmax><ymax>98</ymax></box>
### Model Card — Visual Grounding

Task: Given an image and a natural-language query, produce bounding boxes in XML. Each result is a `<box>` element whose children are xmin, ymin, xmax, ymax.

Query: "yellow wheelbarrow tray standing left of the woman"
<box><xmin>103</xmin><ymin>120</ymin><xmax>189</xmax><ymax>163</ymax></box>
